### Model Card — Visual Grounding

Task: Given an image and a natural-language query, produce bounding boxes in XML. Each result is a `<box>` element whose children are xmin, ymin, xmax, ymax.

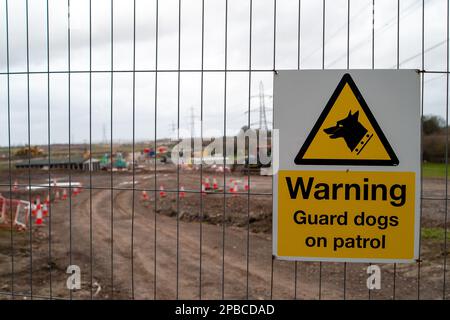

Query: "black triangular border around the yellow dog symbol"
<box><xmin>294</xmin><ymin>73</ymin><xmax>399</xmax><ymax>166</ymax></box>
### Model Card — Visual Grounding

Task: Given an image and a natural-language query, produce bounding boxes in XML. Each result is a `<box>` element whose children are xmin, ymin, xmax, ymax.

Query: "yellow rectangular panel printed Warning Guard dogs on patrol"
<box><xmin>276</xmin><ymin>170</ymin><xmax>415</xmax><ymax>261</ymax></box>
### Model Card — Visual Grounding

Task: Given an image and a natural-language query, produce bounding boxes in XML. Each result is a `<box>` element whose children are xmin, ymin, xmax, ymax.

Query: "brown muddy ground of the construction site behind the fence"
<box><xmin>0</xmin><ymin>165</ymin><xmax>450</xmax><ymax>299</ymax></box>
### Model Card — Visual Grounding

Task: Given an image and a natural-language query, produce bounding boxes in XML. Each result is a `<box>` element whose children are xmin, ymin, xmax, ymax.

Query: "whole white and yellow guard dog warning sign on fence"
<box><xmin>273</xmin><ymin>70</ymin><xmax>421</xmax><ymax>262</ymax></box>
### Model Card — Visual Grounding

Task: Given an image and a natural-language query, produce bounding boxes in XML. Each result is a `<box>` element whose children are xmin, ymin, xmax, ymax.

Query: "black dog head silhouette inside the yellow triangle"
<box><xmin>323</xmin><ymin>110</ymin><xmax>367</xmax><ymax>151</ymax></box>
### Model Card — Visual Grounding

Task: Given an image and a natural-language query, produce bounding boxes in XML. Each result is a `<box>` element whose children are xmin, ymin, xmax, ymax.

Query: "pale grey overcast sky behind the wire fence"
<box><xmin>0</xmin><ymin>0</ymin><xmax>448</xmax><ymax>146</ymax></box>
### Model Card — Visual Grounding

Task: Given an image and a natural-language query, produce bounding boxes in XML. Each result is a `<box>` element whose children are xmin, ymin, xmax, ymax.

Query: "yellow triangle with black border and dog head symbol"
<box><xmin>295</xmin><ymin>74</ymin><xmax>399</xmax><ymax>166</ymax></box>
